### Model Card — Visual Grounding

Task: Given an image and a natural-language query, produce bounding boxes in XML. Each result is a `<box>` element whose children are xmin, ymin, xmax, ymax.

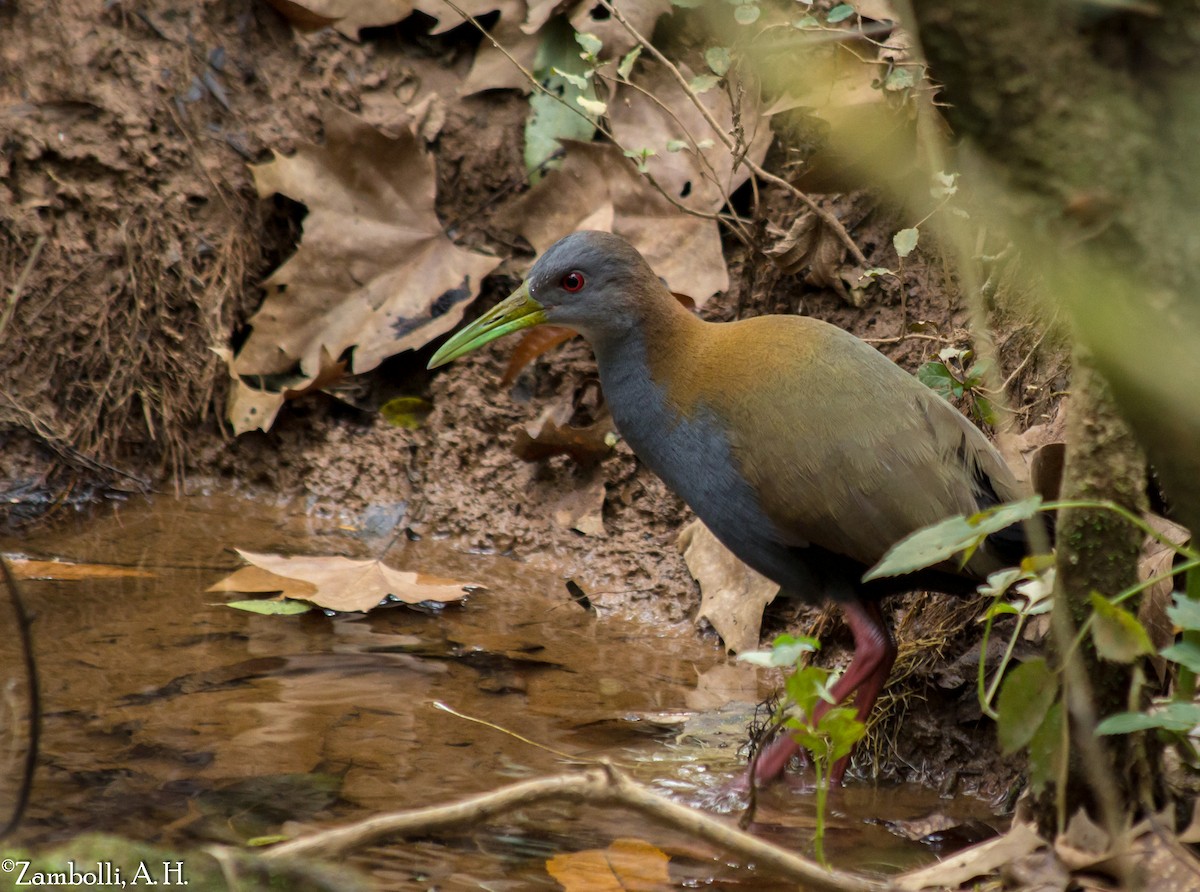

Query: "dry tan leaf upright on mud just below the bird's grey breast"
<box><xmin>677</xmin><ymin>520</ymin><xmax>779</xmax><ymax>653</ymax></box>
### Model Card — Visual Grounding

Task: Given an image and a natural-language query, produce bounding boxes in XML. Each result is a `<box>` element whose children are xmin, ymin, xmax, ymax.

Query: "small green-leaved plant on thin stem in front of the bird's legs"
<box><xmin>738</xmin><ymin>635</ymin><xmax>866</xmax><ymax>864</ymax></box>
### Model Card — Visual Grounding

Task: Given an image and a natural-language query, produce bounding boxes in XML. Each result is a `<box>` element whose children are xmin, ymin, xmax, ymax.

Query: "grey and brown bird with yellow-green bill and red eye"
<box><xmin>428</xmin><ymin>231</ymin><xmax>1028</xmax><ymax>784</ymax></box>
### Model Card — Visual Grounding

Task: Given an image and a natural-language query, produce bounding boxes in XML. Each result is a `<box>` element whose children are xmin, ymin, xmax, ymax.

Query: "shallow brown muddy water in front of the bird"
<box><xmin>0</xmin><ymin>496</ymin><xmax>1003</xmax><ymax>890</ymax></box>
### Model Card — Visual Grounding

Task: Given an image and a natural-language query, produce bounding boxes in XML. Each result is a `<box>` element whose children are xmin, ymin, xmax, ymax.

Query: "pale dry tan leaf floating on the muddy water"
<box><xmin>209</xmin><ymin>549</ymin><xmax>481</xmax><ymax>612</ymax></box>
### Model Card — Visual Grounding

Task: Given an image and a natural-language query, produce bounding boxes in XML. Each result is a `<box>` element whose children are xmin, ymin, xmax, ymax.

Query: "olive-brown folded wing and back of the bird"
<box><xmin>679</xmin><ymin>317</ymin><xmax>1019</xmax><ymax>564</ymax></box>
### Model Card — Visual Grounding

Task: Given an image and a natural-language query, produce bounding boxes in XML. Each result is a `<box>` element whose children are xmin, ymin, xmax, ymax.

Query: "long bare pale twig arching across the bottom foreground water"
<box><xmin>263</xmin><ymin>765</ymin><xmax>887</xmax><ymax>892</ymax></box>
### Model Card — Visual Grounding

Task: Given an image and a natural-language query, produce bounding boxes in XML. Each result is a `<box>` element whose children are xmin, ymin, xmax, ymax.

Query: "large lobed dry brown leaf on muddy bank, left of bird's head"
<box><xmin>229</xmin><ymin>106</ymin><xmax>499</xmax><ymax>433</ymax></box>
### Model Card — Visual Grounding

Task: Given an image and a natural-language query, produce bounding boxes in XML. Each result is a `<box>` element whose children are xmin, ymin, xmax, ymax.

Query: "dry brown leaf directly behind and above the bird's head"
<box><xmin>504</xmin><ymin>140</ymin><xmax>730</xmax><ymax>305</ymax></box>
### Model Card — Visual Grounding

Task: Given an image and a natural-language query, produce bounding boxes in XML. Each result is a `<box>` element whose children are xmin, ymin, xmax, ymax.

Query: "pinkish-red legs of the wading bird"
<box><xmin>755</xmin><ymin>601</ymin><xmax>896</xmax><ymax>784</ymax></box>
